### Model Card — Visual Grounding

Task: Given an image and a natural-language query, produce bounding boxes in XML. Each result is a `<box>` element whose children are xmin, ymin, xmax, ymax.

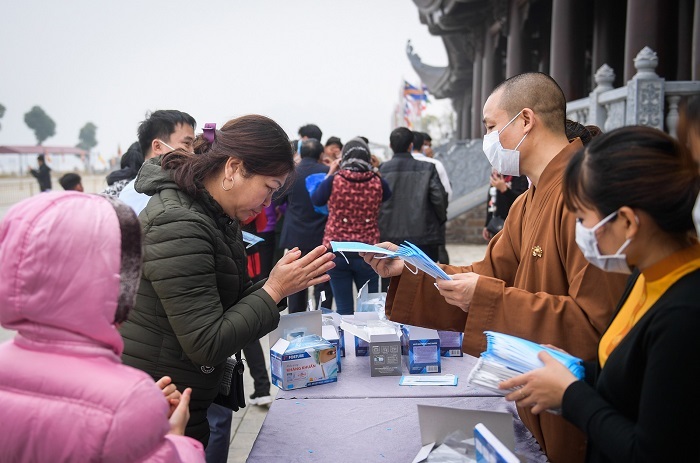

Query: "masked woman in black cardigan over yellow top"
<box><xmin>500</xmin><ymin>126</ymin><xmax>700</xmax><ymax>462</ymax></box>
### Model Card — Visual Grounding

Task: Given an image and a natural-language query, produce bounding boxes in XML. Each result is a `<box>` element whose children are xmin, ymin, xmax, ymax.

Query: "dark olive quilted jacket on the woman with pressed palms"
<box><xmin>120</xmin><ymin>158</ymin><xmax>280</xmax><ymax>445</ymax></box>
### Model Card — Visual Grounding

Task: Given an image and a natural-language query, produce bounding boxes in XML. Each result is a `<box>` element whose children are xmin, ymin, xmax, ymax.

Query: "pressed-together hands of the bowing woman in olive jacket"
<box><xmin>263</xmin><ymin>246</ymin><xmax>335</xmax><ymax>303</ymax></box>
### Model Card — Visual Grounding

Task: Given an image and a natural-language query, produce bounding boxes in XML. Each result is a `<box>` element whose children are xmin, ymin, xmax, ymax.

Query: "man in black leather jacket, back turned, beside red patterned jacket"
<box><xmin>379</xmin><ymin>127</ymin><xmax>447</xmax><ymax>261</ymax></box>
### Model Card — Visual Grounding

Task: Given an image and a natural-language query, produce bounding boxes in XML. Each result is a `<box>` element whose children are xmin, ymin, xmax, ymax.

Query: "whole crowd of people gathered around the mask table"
<box><xmin>0</xmin><ymin>73</ymin><xmax>700</xmax><ymax>463</ymax></box>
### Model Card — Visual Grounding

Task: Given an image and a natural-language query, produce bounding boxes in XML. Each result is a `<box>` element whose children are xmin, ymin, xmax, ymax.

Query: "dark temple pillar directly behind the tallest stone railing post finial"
<box><xmin>624</xmin><ymin>0</ymin><xmax>663</xmax><ymax>81</ymax></box>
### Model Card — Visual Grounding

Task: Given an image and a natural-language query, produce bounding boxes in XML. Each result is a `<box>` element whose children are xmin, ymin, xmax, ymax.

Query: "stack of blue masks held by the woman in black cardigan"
<box><xmin>467</xmin><ymin>331</ymin><xmax>584</xmax><ymax>395</ymax></box>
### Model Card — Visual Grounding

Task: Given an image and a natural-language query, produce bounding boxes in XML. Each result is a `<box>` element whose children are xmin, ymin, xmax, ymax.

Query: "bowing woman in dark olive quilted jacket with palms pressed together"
<box><xmin>120</xmin><ymin>115</ymin><xmax>334</xmax><ymax>445</ymax></box>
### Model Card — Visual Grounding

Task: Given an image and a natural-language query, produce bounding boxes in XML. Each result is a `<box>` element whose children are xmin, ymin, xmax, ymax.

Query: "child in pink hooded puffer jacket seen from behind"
<box><xmin>0</xmin><ymin>192</ymin><xmax>204</xmax><ymax>462</ymax></box>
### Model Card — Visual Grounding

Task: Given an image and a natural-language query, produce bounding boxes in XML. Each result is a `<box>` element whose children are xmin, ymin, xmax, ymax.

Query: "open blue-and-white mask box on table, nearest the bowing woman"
<box><xmin>269</xmin><ymin>310</ymin><xmax>338</xmax><ymax>390</ymax></box>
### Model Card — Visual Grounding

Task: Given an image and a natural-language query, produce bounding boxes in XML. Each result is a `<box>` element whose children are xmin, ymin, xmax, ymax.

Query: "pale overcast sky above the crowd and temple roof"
<box><xmin>0</xmin><ymin>0</ymin><xmax>447</xmax><ymax>163</ymax></box>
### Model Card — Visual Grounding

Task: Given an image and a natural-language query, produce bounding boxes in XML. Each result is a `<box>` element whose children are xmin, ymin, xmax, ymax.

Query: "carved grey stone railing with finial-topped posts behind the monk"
<box><xmin>566</xmin><ymin>47</ymin><xmax>700</xmax><ymax>137</ymax></box>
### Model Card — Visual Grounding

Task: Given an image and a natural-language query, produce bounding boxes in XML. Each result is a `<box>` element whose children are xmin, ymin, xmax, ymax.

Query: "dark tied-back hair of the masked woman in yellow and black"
<box><xmin>564</xmin><ymin>126</ymin><xmax>700</xmax><ymax>234</ymax></box>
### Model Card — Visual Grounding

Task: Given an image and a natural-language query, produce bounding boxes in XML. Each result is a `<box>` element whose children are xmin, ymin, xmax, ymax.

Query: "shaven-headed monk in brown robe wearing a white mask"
<box><xmin>364</xmin><ymin>73</ymin><xmax>626</xmax><ymax>463</ymax></box>
